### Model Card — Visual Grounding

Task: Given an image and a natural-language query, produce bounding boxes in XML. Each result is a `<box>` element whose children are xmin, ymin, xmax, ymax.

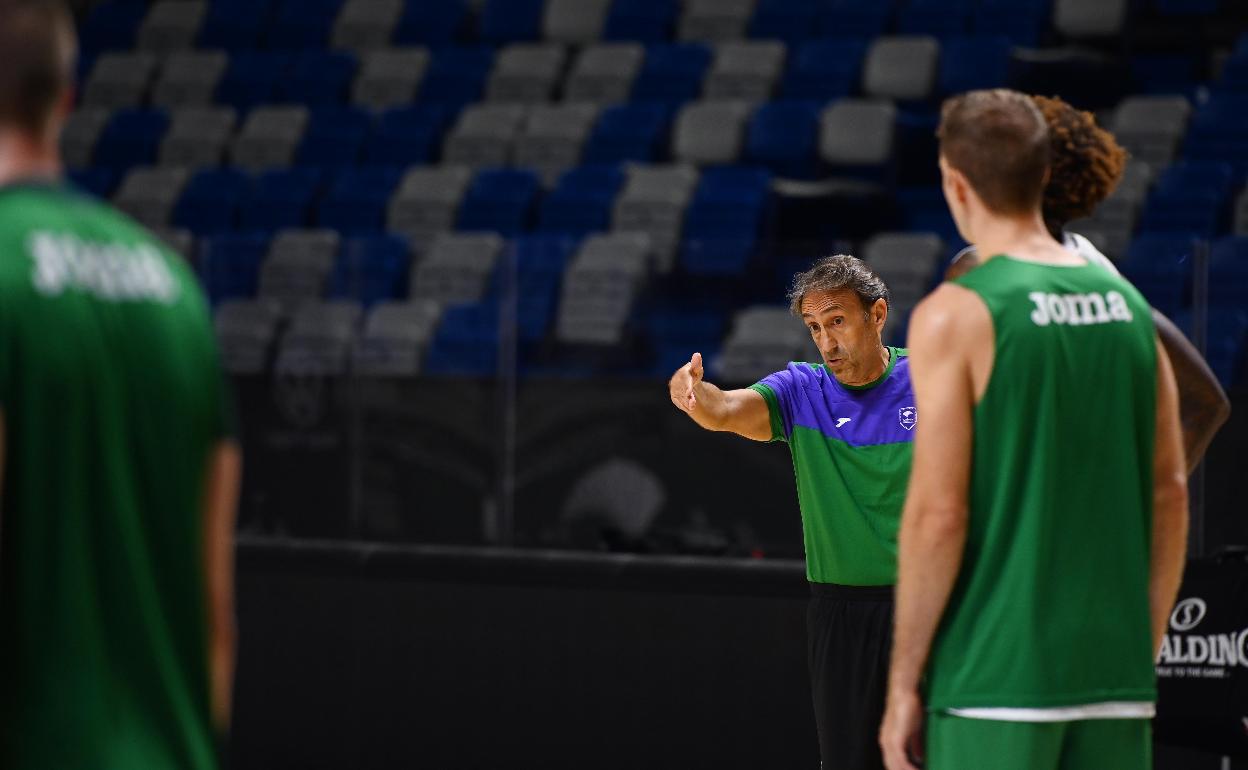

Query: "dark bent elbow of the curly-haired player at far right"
<box><xmin>1153</xmin><ymin>309</ymin><xmax>1231</xmax><ymax>473</ymax></box>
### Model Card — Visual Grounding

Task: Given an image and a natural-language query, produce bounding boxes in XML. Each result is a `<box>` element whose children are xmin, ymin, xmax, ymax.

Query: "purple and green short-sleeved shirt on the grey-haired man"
<box><xmin>750</xmin><ymin>348</ymin><xmax>919</xmax><ymax>585</ymax></box>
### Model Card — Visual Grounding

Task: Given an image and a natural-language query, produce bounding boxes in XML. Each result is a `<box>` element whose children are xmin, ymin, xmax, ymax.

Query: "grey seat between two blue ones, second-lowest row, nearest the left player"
<box><xmin>258</xmin><ymin>230</ymin><xmax>341</xmax><ymax>312</ymax></box>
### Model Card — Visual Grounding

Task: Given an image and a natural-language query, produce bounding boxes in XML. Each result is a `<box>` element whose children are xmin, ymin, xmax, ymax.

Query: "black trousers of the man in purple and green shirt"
<box><xmin>806</xmin><ymin>583</ymin><xmax>892</xmax><ymax>770</ymax></box>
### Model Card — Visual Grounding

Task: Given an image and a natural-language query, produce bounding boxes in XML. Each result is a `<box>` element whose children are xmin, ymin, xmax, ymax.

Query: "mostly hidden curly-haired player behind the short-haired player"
<box><xmin>945</xmin><ymin>96</ymin><xmax>1231</xmax><ymax>473</ymax></box>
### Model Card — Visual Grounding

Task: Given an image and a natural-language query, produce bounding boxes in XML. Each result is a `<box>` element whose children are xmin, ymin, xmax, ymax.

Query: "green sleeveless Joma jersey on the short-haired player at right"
<box><xmin>927</xmin><ymin>256</ymin><xmax>1157</xmax><ymax>710</ymax></box>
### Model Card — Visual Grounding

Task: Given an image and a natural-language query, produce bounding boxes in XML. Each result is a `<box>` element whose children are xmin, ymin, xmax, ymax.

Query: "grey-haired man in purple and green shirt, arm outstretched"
<box><xmin>669</xmin><ymin>255</ymin><xmax>919</xmax><ymax>770</ymax></box>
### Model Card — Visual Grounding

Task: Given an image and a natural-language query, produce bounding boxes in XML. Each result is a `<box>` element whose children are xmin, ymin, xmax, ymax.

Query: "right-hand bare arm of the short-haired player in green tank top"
<box><xmin>1148</xmin><ymin>342</ymin><xmax>1187</xmax><ymax>654</ymax></box>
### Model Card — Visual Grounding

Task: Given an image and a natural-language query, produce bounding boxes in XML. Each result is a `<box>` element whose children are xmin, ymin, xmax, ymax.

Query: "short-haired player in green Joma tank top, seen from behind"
<box><xmin>880</xmin><ymin>91</ymin><xmax>1187</xmax><ymax>770</ymax></box>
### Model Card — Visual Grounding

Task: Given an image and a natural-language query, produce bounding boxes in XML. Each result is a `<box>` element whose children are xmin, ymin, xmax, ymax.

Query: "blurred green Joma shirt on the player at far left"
<box><xmin>0</xmin><ymin>185</ymin><xmax>228</xmax><ymax>770</ymax></box>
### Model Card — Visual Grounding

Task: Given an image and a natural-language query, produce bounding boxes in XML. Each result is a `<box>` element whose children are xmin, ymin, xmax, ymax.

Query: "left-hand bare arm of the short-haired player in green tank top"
<box><xmin>880</xmin><ymin>285</ymin><xmax>992</xmax><ymax>770</ymax></box>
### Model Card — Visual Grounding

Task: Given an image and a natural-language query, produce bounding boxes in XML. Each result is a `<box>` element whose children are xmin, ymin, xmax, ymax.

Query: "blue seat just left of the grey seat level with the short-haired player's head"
<box><xmin>745</xmin><ymin>101</ymin><xmax>820</xmax><ymax>178</ymax></box>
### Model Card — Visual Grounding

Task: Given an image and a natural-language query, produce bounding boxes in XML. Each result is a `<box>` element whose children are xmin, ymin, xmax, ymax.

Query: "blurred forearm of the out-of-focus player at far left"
<box><xmin>203</xmin><ymin>441</ymin><xmax>242</xmax><ymax>733</ymax></box>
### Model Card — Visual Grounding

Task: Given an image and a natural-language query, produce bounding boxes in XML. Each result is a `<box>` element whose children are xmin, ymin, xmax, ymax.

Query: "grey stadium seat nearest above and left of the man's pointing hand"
<box><xmin>555</xmin><ymin>232</ymin><xmax>651</xmax><ymax>344</ymax></box>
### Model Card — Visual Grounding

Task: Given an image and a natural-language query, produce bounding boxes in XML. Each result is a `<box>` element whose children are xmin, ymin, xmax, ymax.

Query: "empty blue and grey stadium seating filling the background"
<box><xmin>61</xmin><ymin>0</ymin><xmax>1248</xmax><ymax>383</ymax></box>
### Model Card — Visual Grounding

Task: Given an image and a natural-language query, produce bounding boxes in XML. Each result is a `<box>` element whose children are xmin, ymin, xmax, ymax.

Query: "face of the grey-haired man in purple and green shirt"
<box><xmin>801</xmin><ymin>288</ymin><xmax>889</xmax><ymax>386</ymax></box>
